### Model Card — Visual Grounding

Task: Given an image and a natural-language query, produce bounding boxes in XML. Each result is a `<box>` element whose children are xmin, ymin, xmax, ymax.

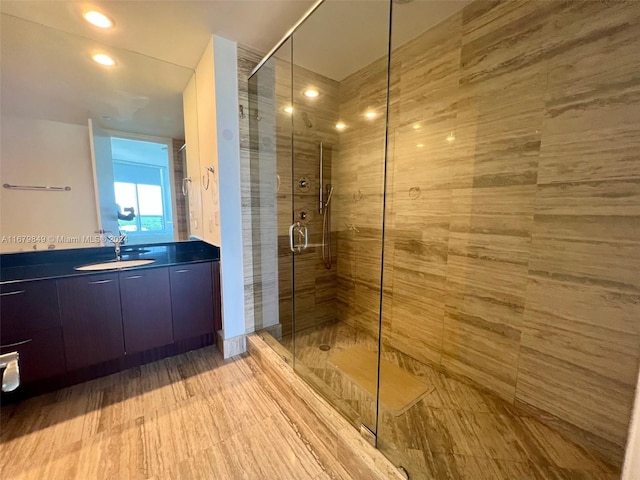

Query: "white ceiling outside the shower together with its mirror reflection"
<box><xmin>0</xmin><ymin>0</ymin><xmax>313</xmax><ymax>138</ymax></box>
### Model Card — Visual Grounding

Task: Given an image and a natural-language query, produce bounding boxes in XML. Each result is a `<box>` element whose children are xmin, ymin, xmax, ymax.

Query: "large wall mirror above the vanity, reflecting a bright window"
<box><xmin>0</xmin><ymin>11</ymin><xmax>197</xmax><ymax>253</ymax></box>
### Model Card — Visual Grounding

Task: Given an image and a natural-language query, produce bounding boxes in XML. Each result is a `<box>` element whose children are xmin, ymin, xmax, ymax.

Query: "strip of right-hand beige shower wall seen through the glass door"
<box><xmin>331</xmin><ymin>52</ymin><xmax>387</xmax><ymax>335</ymax></box>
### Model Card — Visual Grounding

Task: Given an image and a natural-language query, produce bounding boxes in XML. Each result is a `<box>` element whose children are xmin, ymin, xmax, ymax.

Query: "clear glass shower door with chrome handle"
<box><xmin>289</xmin><ymin>1</ymin><xmax>389</xmax><ymax>436</ymax></box>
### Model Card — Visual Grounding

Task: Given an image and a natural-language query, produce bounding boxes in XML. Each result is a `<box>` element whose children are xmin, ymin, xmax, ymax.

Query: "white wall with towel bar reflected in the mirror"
<box><xmin>0</xmin><ymin>115</ymin><xmax>98</xmax><ymax>253</ymax></box>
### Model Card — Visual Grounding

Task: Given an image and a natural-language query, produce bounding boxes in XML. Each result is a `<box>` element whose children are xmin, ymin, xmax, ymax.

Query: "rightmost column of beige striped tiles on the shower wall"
<box><xmin>516</xmin><ymin>2</ymin><xmax>640</xmax><ymax>461</ymax></box>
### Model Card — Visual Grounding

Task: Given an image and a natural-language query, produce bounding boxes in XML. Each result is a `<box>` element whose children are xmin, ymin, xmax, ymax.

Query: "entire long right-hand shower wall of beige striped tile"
<box><xmin>333</xmin><ymin>1</ymin><xmax>640</xmax><ymax>463</ymax></box>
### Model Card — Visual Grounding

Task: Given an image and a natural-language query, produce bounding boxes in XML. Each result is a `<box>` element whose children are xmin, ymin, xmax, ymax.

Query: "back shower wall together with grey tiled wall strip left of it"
<box><xmin>238</xmin><ymin>44</ymin><xmax>338</xmax><ymax>337</ymax></box>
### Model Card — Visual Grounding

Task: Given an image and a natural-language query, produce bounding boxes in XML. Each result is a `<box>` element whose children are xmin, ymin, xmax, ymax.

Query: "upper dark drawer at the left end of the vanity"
<box><xmin>0</xmin><ymin>280</ymin><xmax>60</xmax><ymax>344</ymax></box>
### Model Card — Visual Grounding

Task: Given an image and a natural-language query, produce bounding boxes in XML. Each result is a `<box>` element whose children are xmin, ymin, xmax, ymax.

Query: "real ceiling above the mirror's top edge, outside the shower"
<box><xmin>0</xmin><ymin>0</ymin><xmax>314</xmax><ymax>69</ymax></box>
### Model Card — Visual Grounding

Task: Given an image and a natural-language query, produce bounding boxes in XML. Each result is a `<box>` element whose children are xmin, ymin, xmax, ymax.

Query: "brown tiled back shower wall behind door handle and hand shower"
<box><xmin>276</xmin><ymin>62</ymin><xmax>338</xmax><ymax>335</ymax></box>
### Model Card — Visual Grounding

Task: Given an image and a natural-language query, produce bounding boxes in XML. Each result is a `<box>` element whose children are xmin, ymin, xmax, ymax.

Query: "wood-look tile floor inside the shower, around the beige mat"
<box><xmin>281</xmin><ymin>322</ymin><xmax>620</xmax><ymax>480</ymax></box>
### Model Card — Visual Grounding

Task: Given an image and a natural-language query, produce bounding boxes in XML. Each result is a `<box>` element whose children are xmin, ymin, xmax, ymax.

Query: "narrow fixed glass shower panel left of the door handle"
<box><xmin>249</xmin><ymin>40</ymin><xmax>293</xmax><ymax>364</ymax></box>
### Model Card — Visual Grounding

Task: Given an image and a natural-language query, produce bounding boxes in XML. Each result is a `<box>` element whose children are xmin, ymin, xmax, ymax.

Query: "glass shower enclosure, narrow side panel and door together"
<box><xmin>249</xmin><ymin>2</ymin><xmax>389</xmax><ymax>438</ymax></box>
